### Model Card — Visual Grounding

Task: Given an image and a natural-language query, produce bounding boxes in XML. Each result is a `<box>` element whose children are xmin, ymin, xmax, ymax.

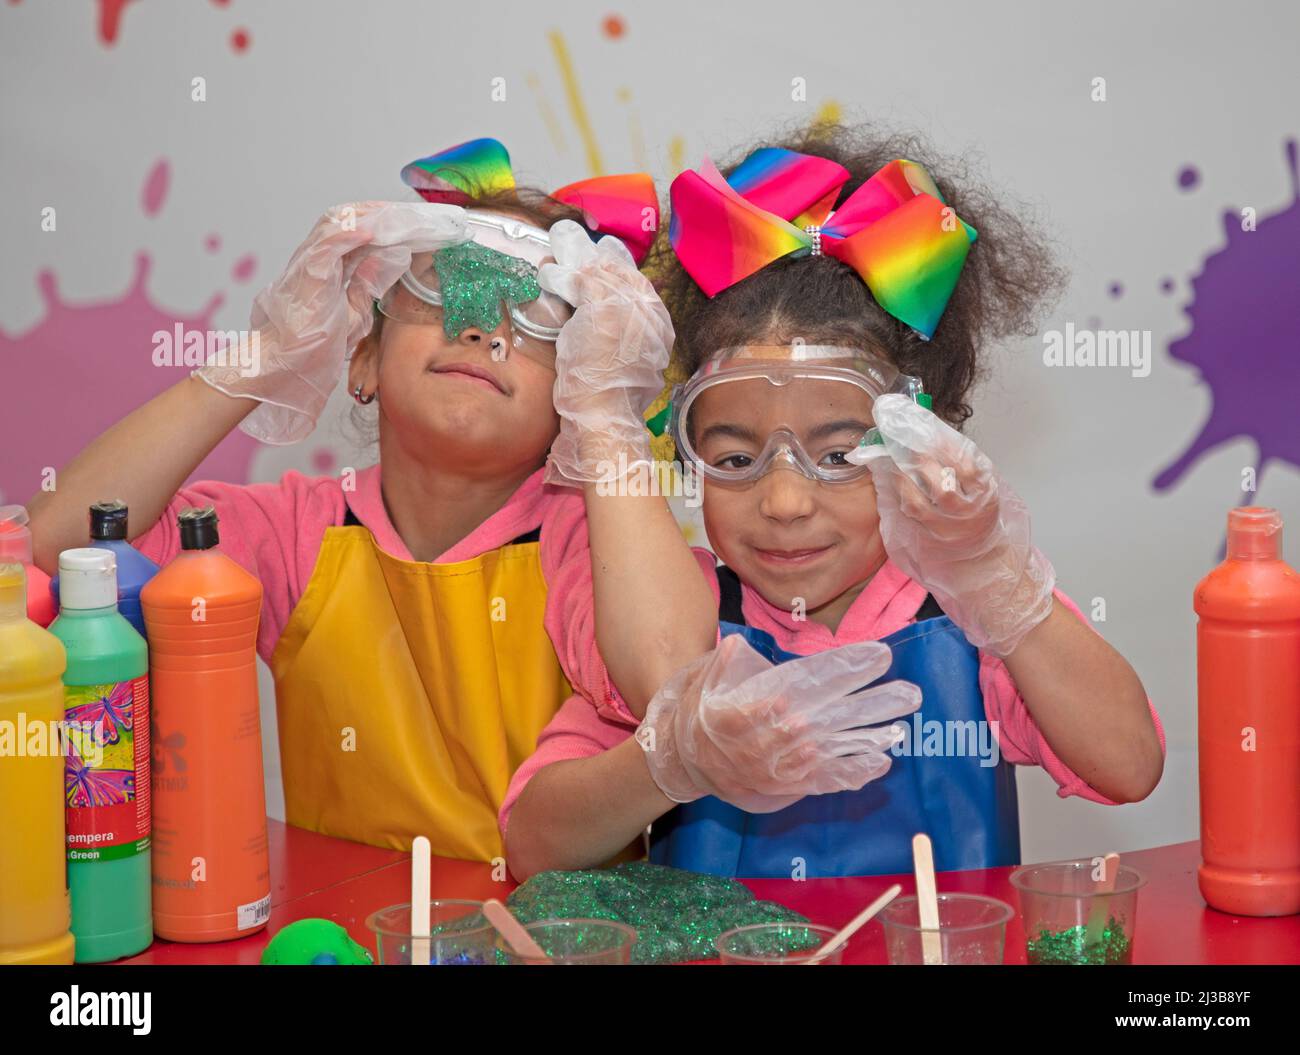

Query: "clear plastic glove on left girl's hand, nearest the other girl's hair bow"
<box><xmin>537</xmin><ymin>220</ymin><xmax>673</xmax><ymax>485</ymax></box>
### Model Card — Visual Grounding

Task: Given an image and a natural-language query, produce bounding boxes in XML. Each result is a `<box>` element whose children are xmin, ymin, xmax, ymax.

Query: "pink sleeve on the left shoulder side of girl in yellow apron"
<box><xmin>131</xmin><ymin>472</ymin><xmax>343</xmax><ymax>661</ymax></box>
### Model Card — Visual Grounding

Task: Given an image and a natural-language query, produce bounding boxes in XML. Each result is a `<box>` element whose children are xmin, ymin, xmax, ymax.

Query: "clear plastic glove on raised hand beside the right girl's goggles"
<box><xmin>853</xmin><ymin>394</ymin><xmax>1056</xmax><ymax>657</ymax></box>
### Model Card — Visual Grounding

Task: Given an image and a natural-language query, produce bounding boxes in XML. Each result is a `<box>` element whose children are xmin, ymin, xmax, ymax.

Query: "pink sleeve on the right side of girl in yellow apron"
<box><xmin>542</xmin><ymin>487</ymin><xmax>714</xmax><ymax>725</ymax></box>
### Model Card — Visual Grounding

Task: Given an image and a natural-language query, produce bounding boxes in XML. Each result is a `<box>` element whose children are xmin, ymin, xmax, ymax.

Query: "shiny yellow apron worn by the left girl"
<box><xmin>270</xmin><ymin>517</ymin><xmax>572</xmax><ymax>861</ymax></box>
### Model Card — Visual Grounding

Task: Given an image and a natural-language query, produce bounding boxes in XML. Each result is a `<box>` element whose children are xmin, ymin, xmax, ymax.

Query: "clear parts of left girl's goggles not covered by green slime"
<box><xmin>378</xmin><ymin>212</ymin><xmax>573</xmax><ymax>344</ymax></box>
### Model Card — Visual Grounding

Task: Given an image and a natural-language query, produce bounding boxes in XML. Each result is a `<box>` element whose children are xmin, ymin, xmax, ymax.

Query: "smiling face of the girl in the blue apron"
<box><xmin>692</xmin><ymin>366</ymin><xmax>885</xmax><ymax>629</ymax></box>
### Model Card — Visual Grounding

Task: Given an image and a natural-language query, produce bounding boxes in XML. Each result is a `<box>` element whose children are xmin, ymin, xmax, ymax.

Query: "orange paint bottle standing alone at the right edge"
<box><xmin>1195</xmin><ymin>507</ymin><xmax>1300</xmax><ymax>916</ymax></box>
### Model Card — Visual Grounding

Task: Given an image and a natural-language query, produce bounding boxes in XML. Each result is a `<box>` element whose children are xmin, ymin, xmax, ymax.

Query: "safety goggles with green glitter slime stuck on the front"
<box><xmin>378</xmin><ymin>212</ymin><xmax>573</xmax><ymax>345</ymax></box>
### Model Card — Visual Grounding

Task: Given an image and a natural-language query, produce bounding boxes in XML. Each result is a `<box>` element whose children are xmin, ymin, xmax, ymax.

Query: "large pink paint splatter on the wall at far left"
<box><xmin>0</xmin><ymin>162</ymin><xmax>257</xmax><ymax>502</ymax></box>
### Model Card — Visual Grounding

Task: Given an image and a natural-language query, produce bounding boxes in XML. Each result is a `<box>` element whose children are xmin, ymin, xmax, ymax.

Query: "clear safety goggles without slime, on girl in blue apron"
<box><xmin>671</xmin><ymin>344</ymin><xmax>919</xmax><ymax>483</ymax></box>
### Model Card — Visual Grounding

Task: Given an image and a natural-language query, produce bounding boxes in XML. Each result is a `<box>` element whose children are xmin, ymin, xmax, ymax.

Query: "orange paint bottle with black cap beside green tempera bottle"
<box><xmin>140</xmin><ymin>505</ymin><xmax>270</xmax><ymax>942</ymax></box>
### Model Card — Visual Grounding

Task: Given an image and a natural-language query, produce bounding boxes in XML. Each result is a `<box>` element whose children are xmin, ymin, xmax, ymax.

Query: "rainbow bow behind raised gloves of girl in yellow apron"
<box><xmin>402</xmin><ymin>139</ymin><xmax>659</xmax><ymax>264</ymax></box>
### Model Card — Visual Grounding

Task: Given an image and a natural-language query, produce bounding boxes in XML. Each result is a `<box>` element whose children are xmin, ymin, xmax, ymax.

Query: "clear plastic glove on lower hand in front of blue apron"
<box><xmin>637</xmin><ymin>634</ymin><xmax>920</xmax><ymax>813</ymax></box>
